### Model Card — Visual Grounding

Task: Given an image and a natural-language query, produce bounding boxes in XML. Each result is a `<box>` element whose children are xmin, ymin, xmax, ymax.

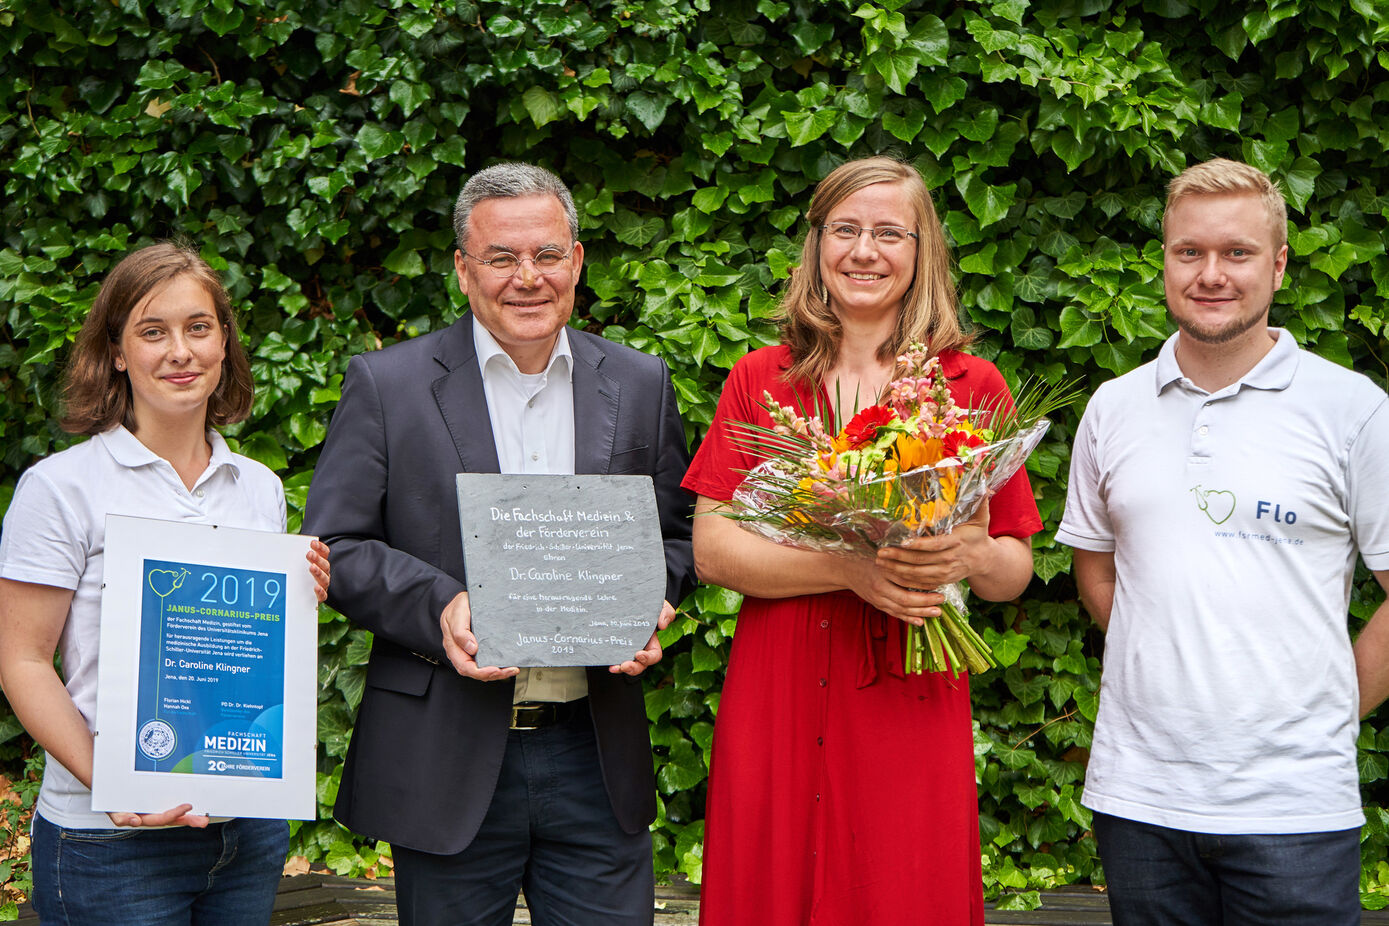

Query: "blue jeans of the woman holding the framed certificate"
<box><xmin>31</xmin><ymin>814</ymin><xmax>289</xmax><ymax>926</ymax></box>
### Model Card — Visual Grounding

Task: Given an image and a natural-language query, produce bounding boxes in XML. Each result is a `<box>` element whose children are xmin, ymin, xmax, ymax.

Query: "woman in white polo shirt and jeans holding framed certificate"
<box><xmin>0</xmin><ymin>244</ymin><xmax>328</xmax><ymax>926</ymax></box>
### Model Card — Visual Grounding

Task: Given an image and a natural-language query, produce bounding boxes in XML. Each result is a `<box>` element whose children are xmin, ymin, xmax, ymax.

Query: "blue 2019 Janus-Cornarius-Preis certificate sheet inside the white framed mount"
<box><xmin>135</xmin><ymin>559</ymin><xmax>286</xmax><ymax>779</ymax></box>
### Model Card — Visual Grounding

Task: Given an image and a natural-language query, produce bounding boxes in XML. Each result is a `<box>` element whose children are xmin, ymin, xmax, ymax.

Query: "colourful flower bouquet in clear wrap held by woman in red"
<box><xmin>726</xmin><ymin>344</ymin><xmax>1076</xmax><ymax>676</ymax></box>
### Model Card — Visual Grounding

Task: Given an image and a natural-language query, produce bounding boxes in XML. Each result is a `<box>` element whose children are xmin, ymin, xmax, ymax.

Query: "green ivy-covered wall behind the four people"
<box><xmin>0</xmin><ymin>0</ymin><xmax>1389</xmax><ymax>907</ymax></box>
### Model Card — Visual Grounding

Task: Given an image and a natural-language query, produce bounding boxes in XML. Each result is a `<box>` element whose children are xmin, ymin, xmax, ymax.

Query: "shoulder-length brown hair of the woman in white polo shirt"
<box><xmin>61</xmin><ymin>242</ymin><xmax>254</xmax><ymax>435</ymax></box>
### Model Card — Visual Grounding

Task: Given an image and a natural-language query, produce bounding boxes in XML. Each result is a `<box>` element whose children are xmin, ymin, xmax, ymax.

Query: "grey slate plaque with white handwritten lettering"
<box><xmin>457</xmin><ymin>473</ymin><xmax>665</xmax><ymax>666</ymax></box>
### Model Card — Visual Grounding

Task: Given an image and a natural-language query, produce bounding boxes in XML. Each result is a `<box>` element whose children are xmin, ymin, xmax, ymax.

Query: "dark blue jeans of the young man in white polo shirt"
<box><xmin>1093</xmin><ymin>814</ymin><xmax>1360</xmax><ymax>926</ymax></box>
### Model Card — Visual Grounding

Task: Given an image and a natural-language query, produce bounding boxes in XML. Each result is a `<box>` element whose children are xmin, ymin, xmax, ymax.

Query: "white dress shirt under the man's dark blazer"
<box><xmin>472</xmin><ymin>317</ymin><xmax>589</xmax><ymax>704</ymax></box>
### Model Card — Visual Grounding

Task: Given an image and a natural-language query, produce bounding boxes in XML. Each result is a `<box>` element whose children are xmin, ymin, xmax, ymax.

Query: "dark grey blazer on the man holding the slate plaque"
<box><xmin>303</xmin><ymin>315</ymin><xmax>693</xmax><ymax>854</ymax></box>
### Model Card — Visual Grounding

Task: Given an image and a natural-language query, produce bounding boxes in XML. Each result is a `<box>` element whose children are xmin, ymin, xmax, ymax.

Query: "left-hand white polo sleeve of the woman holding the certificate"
<box><xmin>0</xmin><ymin>468</ymin><xmax>90</xmax><ymax>589</ymax></box>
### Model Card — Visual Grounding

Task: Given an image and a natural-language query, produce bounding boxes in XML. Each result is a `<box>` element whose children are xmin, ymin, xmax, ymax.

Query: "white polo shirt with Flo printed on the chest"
<box><xmin>1057</xmin><ymin>329</ymin><xmax>1389</xmax><ymax>833</ymax></box>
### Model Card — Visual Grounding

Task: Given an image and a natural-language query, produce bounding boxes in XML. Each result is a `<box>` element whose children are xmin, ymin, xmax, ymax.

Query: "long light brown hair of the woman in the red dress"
<box><xmin>781</xmin><ymin>157</ymin><xmax>970</xmax><ymax>383</ymax></box>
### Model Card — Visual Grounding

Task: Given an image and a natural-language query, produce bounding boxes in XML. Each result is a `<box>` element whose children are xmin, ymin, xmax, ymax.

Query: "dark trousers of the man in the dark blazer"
<box><xmin>393</xmin><ymin>711</ymin><xmax>656</xmax><ymax>926</ymax></box>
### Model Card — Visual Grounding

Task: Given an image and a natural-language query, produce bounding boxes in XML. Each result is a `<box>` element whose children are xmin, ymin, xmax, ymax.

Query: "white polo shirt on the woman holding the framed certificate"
<box><xmin>0</xmin><ymin>426</ymin><xmax>285</xmax><ymax>829</ymax></box>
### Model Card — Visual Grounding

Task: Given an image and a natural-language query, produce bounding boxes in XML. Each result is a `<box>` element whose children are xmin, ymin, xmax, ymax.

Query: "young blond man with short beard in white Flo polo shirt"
<box><xmin>1057</xmin><ymin>160</ymin><xmax>1389</xmax><ymax>926</ymax></box>
